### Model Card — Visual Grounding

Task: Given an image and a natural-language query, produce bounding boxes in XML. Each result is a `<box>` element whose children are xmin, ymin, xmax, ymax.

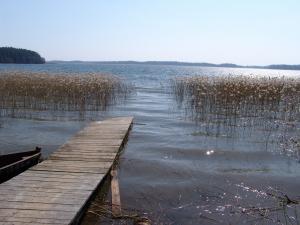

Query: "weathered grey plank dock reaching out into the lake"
<box><xmin>0</xmin><ymin>117</ymin><xmax>133</xmax><ymax>225</ymax></box>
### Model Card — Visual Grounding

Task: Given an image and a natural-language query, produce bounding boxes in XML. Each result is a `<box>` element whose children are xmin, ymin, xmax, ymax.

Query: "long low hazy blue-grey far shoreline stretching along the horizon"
<box><xmin>48</xmin><ymin>60</ymin><xmax>300</xmax><ymax>70</ymax></box>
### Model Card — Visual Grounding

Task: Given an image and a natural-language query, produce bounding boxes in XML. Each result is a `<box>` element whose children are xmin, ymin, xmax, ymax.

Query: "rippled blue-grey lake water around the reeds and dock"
<box><xmin>0</xmin><ymin>63</ymin><xmax>300</xmax><ymax>224</ymax></box>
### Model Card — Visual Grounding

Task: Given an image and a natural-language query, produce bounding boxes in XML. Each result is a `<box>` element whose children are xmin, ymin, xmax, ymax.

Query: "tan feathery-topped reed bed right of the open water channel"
<box><xmin>172</xmin><ymin>76</ymin><xmax>300</xmax><ymax>125</ymax></box>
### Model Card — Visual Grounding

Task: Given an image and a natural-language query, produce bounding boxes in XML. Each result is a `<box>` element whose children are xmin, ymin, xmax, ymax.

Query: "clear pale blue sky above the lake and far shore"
<box><xmin>0</xmin><ymin>0</ymin><xmax>300</xmax><ymax>65</ymax></box>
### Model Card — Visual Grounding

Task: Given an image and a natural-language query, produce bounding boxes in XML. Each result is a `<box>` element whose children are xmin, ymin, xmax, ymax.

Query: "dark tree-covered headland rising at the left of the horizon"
<box><xmin>0</xmin><ymin>47</ymin><xmax>45</xmax><ymax>64</ymax></box>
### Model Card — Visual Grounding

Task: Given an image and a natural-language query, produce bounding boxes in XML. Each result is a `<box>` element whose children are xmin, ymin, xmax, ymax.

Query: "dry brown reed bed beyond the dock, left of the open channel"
<box><xmin>0</xmin><ymin>72</ymin><xmax>129</xmax><ymax>119</ymax></box>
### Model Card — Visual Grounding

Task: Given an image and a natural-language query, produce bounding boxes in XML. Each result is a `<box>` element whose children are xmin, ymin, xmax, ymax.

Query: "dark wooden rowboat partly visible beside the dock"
<box><xmin>0</xmin><ymin>147</ymin><xmax>41</xmax><ymax>184</ymax></box>
